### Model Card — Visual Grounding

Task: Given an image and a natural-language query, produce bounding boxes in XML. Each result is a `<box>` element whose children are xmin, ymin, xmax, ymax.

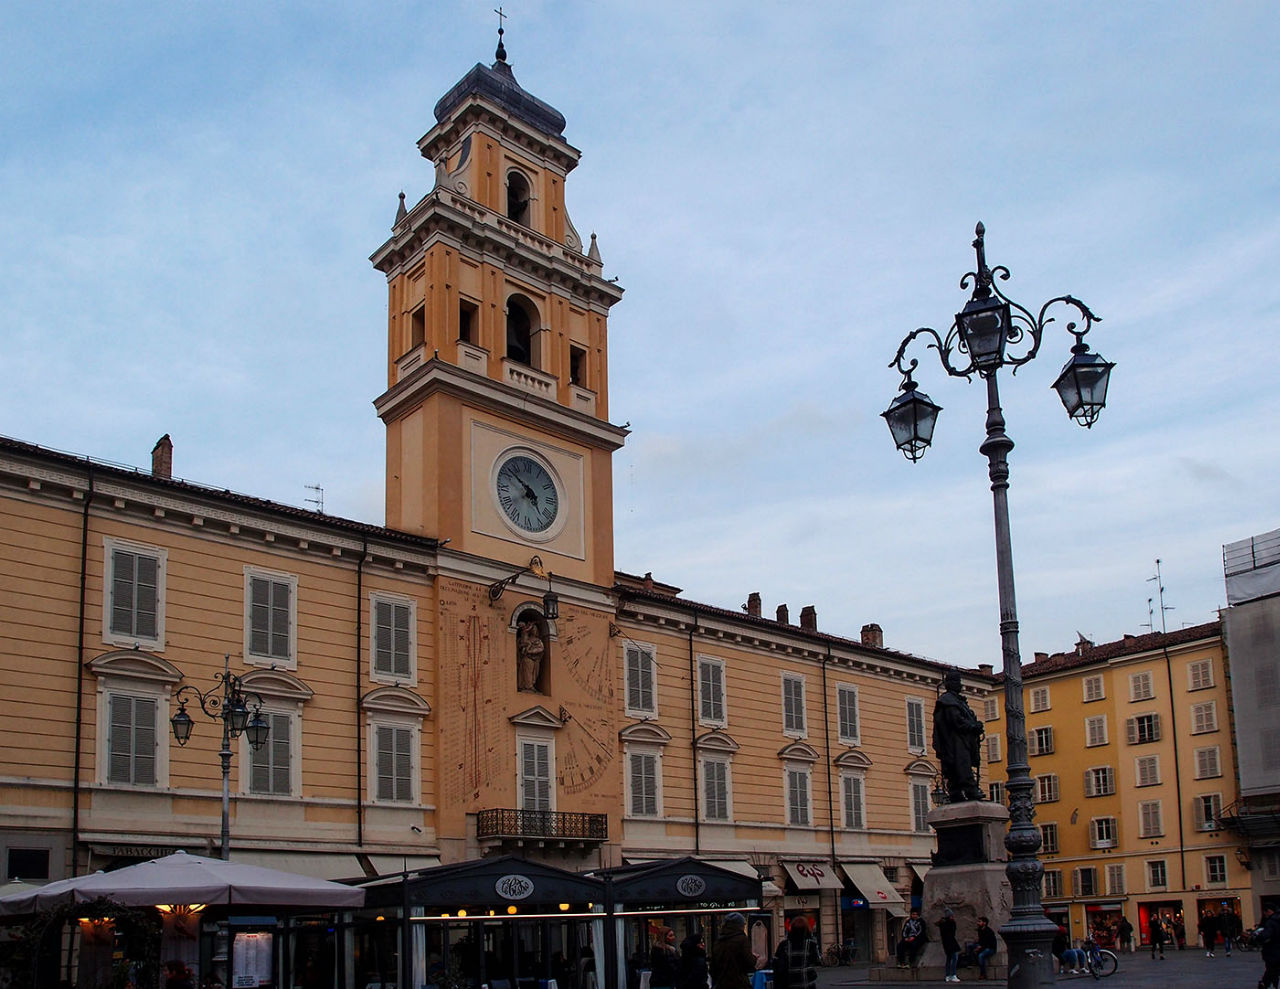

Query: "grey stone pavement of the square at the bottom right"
<box><xmin>818</xmin><ymin>947</ymin><xmax>1262</xmax><ymax>989</ymax></box>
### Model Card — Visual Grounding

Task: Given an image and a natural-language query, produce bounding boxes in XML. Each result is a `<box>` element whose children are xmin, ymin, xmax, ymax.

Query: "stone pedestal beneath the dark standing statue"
<box><xmin>920</xmin><ymin>800</ymin><xmax>1014</xmax><ymax>980</ymax></box>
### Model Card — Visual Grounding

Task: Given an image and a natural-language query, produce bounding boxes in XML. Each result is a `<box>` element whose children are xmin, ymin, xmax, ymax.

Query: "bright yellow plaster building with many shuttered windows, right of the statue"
<box><xmin>983</xmin><ymin>622</ymin><xmax>1256</xmax><ymax>947</ymax></box>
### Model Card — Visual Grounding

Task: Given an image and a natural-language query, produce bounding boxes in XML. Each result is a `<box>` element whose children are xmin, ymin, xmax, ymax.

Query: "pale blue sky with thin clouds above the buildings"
<box><xmin>0</xmin><ymin>0</ymin><xmax>1280</xmax><ymax>668</ymax></box>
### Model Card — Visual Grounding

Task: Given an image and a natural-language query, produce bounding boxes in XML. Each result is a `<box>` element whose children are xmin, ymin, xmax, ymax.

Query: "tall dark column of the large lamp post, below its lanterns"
<box><xmin>979</xmin><ymin>371</ymin><xmax>1057</xmax><ymax>989</ymax></box>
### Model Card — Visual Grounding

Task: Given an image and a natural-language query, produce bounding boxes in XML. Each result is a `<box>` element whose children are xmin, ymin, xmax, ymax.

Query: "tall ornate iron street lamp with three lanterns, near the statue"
<box><xmin>882</xmin><ymin>223</ymin><xmax>1115</xmax><ymax>989</ymax></box>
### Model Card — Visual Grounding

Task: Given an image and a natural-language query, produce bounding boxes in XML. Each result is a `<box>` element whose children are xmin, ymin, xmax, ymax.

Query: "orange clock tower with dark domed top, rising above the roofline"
<box><xmin>371</xmin><ymin>44</ymin><xmax>626</xmax><ymax>587</ymax></box>
